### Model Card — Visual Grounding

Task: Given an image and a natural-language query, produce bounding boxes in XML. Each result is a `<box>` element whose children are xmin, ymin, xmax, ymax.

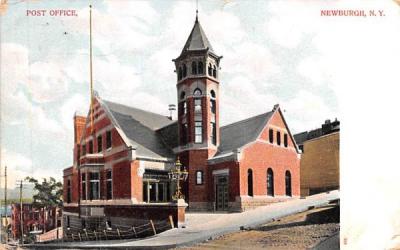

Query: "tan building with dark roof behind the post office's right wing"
<box><xmin>294</xmin><ymin>119</ymin><xmax>340</xmax><ymax>196</ymax></box>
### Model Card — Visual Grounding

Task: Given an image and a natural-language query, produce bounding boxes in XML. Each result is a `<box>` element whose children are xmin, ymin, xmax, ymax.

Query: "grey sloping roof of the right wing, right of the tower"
<box><xmin>214</xmin><ymin>111</ymin><xmax>274</xmax><ymax>157</ymax></box>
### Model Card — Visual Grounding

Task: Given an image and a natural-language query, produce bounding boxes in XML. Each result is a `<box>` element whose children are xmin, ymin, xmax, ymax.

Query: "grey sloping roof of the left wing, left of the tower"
<box><xmin>101</xmin><ymin>100</ymin><xmax>174</xmax><ymax>159</ymax></box>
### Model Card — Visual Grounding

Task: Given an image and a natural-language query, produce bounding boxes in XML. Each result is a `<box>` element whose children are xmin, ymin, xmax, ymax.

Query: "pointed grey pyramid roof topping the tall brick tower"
<box><xmin>181</xmin><ymin>17</ymin><xmax>215</xmax><ymax>54</ymax></box>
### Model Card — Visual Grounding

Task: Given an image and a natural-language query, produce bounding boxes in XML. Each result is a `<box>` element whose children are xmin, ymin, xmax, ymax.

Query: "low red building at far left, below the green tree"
<box><xmin>11</xmin><ymin>203</ymin><xmax>62</xmax><ymax>239</ymax></box>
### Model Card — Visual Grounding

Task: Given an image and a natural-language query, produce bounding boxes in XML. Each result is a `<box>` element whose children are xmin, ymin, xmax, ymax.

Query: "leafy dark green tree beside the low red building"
<box><xmin>25</xmin><ymin>176</ymin><xmax>63</xmax><ymax>208</ymax></box>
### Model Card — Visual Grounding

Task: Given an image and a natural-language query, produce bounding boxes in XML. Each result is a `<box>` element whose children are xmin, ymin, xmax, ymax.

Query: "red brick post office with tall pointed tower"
<box><xmin>64</xmin><ymin>17</ymin><xmax>300</xmax><ymax>228</ymax></box>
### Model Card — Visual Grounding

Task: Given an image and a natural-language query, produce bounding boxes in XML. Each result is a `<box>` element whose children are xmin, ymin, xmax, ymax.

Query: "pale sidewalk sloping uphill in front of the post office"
<box><xmin>25</xmin><ymin>191</ymin><xmax>339</xmax><ymax>249</ymax></box>
